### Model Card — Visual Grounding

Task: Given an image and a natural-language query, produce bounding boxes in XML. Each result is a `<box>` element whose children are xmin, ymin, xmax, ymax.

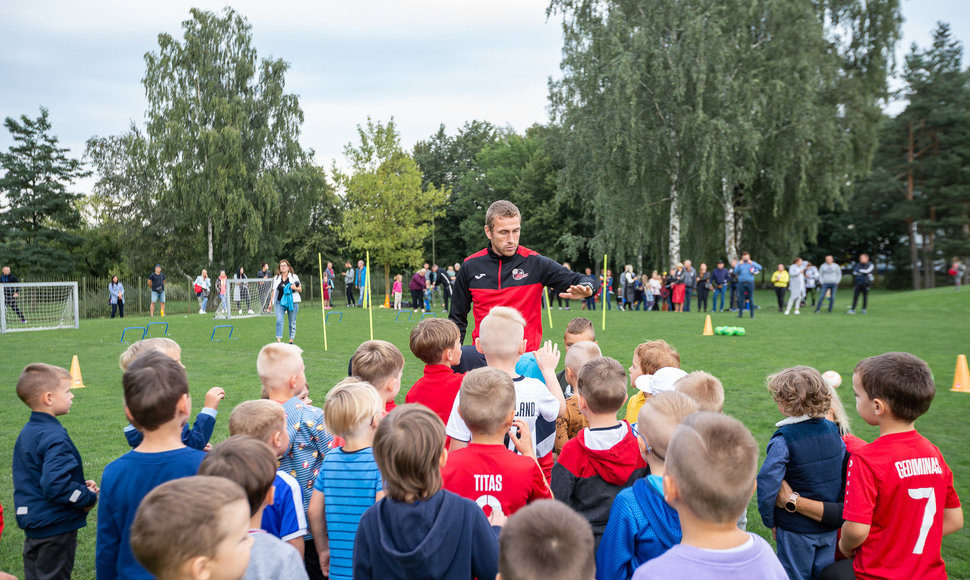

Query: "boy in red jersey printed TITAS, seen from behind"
<box><xmin>441</xmin><ymin>367</ymin><xmax>552</xmax><ymax>516</ymax></box>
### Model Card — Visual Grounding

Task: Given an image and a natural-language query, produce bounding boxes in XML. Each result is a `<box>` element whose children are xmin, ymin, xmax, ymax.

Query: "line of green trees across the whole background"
<box><xmin>0</xmin><ymin>0</ymin><xmax>970</xmax><ymax>288</ymax></box>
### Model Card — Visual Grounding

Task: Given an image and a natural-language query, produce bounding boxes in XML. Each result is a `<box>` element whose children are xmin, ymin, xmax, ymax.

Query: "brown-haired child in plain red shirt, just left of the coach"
<box><xmin>404</xmin><ymin>318</ymin><xmax>465</xmax><ymax>424</ymax></box>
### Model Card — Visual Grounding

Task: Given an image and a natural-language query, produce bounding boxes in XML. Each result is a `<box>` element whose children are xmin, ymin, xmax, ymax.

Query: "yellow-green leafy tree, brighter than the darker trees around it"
<box><xmin>332</xmin><ymin>117</ymin><xmax>448</xmax><ymax>288</ymax></box>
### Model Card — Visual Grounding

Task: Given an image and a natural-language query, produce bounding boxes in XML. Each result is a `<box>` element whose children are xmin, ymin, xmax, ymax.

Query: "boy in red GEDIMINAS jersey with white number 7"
<box><xmin>839</xmin><ymin>352</ymin><xmax>963</xmax><ymax>580</ymax></box>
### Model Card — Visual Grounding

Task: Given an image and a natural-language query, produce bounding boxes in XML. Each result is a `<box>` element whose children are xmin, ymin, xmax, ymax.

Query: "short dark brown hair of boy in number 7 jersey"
<box><xmin>855</xmin><ymin>352</ymin><xmax>936</xmax><ymax>422</ymax></box>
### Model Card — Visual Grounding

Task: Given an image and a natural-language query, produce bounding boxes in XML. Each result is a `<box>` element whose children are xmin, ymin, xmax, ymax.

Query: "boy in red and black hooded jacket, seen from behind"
<box><xmin>551</xmin><ymin>356</ymin><xmax>647</xmax><ymax>547</ymax></box>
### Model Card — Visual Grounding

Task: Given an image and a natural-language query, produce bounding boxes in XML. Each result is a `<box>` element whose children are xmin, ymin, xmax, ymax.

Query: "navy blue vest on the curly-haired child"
<box><xmin>775</xmin><ymin>418</ymin><xmax>845</xmax><ymax>534</ymax></box>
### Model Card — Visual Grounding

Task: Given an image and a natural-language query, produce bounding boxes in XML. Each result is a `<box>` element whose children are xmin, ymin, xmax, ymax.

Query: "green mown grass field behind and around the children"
<box><xmin>0</xmin><ymin>288</ymin><xmax>970</xmax><ymax>578</ymax></box>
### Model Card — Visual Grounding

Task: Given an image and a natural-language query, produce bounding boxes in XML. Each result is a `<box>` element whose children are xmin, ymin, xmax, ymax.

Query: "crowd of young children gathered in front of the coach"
<box><xmin>7</xmin><ymin>307</ymin><xmax>963</xmax><ymax>580</ymax></box>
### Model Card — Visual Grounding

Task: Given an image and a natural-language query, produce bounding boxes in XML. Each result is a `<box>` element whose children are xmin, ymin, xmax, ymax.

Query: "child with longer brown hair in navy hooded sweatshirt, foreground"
<box><xmin>353</xmin><ymin>403</ymin><xmax>506</xmax><ymax>580</ymax></box>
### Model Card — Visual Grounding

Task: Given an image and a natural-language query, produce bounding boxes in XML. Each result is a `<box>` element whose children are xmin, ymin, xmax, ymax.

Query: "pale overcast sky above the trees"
<box><xmin>0</xmin><ymin>0</ymin><xmax>970</xmax><ymax>190</ymax></box>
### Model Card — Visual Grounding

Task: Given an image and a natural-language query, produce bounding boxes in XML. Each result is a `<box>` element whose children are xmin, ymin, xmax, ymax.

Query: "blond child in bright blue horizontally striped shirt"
<box><xmin>307</xmin><ymin>377</ymin><xmax>384</xmax><ymax>580</ymax></box>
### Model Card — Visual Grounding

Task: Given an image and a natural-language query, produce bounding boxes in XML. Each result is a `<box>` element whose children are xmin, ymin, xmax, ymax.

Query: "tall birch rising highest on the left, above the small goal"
<box><xmin>143</xmin><ymin>8</ymin><xmax>320</xmax><ymax>265</ymax></box>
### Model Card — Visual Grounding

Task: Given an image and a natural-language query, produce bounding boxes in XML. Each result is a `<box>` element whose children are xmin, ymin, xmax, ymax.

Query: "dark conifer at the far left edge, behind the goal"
<box><xmin>0</xmin><ymin>107</ymin><xmax>88</xmax><ymax>276</ymax></box>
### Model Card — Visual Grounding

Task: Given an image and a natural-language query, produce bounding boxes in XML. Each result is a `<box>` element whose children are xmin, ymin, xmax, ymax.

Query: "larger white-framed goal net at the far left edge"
<box><xmin>0</xmin><ymin>282</ymin><xmax>78</xmax><ymax>332</ymax></box>
